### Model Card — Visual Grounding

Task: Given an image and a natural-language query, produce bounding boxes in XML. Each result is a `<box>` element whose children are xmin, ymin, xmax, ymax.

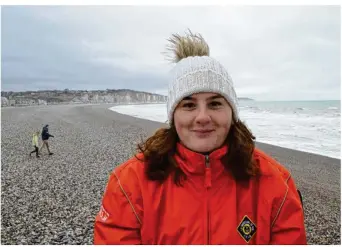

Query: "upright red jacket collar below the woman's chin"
<box><xmin>176</xmin><ymin>143</ymin><xmax>228</xmax><ymax>175</ymax></box>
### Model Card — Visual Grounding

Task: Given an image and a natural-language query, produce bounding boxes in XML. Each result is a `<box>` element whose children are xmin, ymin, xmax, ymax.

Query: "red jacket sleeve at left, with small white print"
<box><xmin>94</xmin><ymin>171</ymin><xmax>141</xmax><ymax>245</ymax></box>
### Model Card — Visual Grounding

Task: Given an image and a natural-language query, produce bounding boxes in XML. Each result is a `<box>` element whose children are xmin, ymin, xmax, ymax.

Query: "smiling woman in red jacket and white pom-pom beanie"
<box><xmin>94</xmin><ymin>29</ymin><xmax>307</xmax><ymax>245</ymax></box>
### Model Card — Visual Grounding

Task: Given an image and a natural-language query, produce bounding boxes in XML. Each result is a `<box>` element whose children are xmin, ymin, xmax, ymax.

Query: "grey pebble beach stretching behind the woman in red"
<box><xmin>1</xmin><ymin>104</ymin><xmax>341</xmax><ymax>245</ymax></box>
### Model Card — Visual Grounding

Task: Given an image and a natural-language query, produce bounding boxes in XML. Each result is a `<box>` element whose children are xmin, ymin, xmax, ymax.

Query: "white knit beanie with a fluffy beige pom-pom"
<box><xmin>167</xmin><ymin>30</ymin><xmax>238</xmax><ymax>124</ymax></box>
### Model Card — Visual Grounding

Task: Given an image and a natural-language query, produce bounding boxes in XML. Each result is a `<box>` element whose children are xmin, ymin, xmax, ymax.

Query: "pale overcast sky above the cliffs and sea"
<box><xmin>1</xmin><ymin>6</ymin><xmax>341</xmax><ymax>100</ymax></box>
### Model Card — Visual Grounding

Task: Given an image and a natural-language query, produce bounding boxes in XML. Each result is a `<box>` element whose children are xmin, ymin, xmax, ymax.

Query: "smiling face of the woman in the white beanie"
<box><xmin>174</xmin><ymin>93</ymin><xmax>232</xmax><ymax>153</ymax></box>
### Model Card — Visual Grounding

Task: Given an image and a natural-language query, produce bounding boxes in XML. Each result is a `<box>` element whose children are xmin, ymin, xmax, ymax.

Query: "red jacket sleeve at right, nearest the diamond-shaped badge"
<box><xmin>270</xmin><ymin>177</ymin><xmax>307</xmax><ymax>245</ymax></box>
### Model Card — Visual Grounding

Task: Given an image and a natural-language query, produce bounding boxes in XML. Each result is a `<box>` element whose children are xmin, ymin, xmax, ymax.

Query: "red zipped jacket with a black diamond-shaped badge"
<box><xmin>94</xmin><ymin>144</ymin><xmax>307</xmax><ymax>245</ymax></box>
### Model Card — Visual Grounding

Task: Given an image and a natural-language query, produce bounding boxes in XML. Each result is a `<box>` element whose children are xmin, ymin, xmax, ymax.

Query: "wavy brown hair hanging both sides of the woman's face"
<box><xmin>136</xmin><ymin>120</ymin><xmax>259</xmax><ymax>185</ymax></box>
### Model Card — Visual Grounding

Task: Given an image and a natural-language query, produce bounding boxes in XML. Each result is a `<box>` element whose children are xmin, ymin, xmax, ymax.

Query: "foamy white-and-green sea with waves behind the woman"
<box><xmin>110</xmin><ymin>100</ymin><xmax>341</xmax><ymax>159</ymax></box>
